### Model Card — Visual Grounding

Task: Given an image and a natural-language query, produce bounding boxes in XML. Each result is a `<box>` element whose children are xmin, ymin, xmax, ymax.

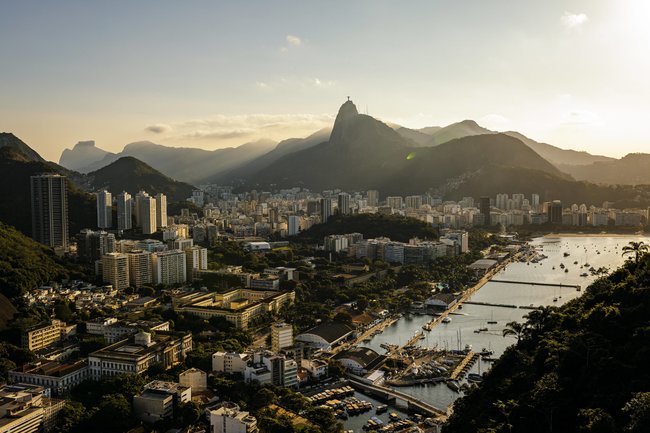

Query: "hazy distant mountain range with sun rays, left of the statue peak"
<box><xmin>61</xmin><ymin>140</ymin><xmax>276</xmax><ymax>183</ymax></box>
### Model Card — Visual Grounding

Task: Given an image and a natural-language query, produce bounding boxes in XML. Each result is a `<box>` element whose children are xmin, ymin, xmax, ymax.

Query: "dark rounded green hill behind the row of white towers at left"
<box><xmin>88</xmin><ymin>156</ymin><xmax>194</xmax><ymax>202</ymax></box>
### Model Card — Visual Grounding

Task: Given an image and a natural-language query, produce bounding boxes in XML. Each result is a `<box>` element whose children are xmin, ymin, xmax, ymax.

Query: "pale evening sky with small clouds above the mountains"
<box><xmin>0</xmin><ymin>0</ymin><xmax>650</xmax><ymax>161</ymax></box>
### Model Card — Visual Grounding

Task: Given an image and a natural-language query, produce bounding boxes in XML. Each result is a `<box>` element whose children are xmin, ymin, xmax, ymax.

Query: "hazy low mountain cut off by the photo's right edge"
<box><xmin>565</xmin><ymin>153</ymin><xmax>650</xmax><ymax>185</ymax></box>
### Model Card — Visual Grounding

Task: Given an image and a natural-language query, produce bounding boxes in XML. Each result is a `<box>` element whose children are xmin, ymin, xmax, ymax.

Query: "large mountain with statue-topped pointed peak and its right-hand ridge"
<box><xmin>239</xmin><ymin>101</ymin><xmax>566</xmax><ymax>194</ymax></box>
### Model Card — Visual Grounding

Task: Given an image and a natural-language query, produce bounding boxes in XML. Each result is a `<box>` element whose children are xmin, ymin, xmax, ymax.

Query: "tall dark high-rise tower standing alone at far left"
<box><xmin>30</xmin><ymin>174</ymin><xmax>68</xmax><ymax>250</ymax></box>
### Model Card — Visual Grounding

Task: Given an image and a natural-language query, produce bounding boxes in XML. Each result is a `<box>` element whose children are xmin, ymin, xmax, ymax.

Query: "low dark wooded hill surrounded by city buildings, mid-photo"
<box><xmin>299</xmin><ymin>214</ymin><xmax>438</xmax><ymax>243</ymax></box>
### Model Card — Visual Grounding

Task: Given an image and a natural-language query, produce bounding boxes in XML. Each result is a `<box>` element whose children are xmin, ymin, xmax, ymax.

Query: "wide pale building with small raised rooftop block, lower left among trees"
<box><xmin>88</xmin><ymin>331</ymin><xmax>192</xmax><ymax>380</ymax></box>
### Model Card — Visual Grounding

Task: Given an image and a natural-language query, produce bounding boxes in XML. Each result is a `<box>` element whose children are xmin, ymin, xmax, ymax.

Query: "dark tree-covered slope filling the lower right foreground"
<box><xmin>445</xmin><ymin>249</ymin><xmax>650</xmax><ymax>433</ymax></box>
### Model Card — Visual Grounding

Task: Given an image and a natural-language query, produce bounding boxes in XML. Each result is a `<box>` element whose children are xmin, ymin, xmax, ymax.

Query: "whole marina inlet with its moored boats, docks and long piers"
<box><xmin>345</xmin><ymin>236</ymin><xmax>648</xmax><ymax>431</ymax></box>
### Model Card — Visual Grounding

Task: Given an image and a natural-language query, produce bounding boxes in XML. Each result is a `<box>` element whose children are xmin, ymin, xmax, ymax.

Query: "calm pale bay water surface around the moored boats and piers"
<box><xmin>346</xmin><ymin>236</ymin><xmax>650</xmax><ymax>414</ymax></box>
